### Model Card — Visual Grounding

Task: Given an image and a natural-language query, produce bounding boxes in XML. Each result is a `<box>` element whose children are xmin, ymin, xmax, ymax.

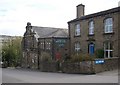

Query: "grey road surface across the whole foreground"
<box><xmin>0</xmin><ymin>68</ymin><xmax>118</xmax><ymax>83</ymax></box>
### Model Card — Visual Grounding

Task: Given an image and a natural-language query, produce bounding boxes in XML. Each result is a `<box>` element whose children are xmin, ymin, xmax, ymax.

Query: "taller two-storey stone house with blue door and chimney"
<box><xmin>68</xmin><ymin>4</ymin><xmax>120</xmax><ymax>58</ymax></box>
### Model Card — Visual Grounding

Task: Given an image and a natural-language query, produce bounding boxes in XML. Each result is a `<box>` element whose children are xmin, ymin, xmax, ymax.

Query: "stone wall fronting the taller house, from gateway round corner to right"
<box><xmin>62</xmin><ymin>58</ymin><xmax>118</xmax><ymax>74</ymax></box>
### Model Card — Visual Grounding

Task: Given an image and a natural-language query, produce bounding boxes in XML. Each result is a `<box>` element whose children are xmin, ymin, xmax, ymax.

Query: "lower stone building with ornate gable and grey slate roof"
<box><xmin>22</xmin><ymin>22</ymin><xmax>69</xmax><ymax>69</ymax></box>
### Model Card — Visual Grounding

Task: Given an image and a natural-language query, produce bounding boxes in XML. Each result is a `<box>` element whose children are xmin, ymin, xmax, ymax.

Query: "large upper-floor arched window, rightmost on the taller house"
<box><xmin>104</xmin><ymin>18</ymin><xmax>113</xmax><ymax>33</ymax></box>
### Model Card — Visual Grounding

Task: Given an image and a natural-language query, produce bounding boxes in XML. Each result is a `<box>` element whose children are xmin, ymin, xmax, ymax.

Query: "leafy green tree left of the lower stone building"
<box><xmin>2</xmin><ymin>37</ymin><xmax>22</xmax><ymax>66</ymax></box>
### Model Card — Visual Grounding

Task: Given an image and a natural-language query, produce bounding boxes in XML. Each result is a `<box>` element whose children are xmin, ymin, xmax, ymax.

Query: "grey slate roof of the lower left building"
<box><xmin>32</xmin><ymin>26</ymin><xmax>68</xmax><ymax>38</ymax></box>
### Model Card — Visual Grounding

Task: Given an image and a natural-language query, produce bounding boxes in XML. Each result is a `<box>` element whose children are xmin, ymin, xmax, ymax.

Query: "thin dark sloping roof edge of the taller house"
<box><xmin>68</xmin><ymin>7</ymin><xmax>120</xmax><ymax>23</ymax></box>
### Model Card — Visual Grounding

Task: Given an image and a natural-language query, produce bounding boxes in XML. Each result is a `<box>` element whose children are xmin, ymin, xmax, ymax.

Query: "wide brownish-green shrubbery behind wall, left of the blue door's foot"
<box><xmin>70</xmin><ymin>53</ymin><xmax>95</xmax><ymax>62</ymax></box>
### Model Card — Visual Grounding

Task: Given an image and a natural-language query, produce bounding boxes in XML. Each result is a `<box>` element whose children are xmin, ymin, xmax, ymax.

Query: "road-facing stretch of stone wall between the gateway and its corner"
<box><xmin>62</xmin><ymin>61</ymin><xmax>94</xmax><ymax>74</ymax></box>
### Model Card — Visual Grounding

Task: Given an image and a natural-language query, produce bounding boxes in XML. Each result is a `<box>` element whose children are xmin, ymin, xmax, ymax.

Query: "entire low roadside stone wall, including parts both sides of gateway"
<box><xmin>21</xmin><ymin>57</ymin><xmax>118</xmax><ymax>74</ymax></box>
